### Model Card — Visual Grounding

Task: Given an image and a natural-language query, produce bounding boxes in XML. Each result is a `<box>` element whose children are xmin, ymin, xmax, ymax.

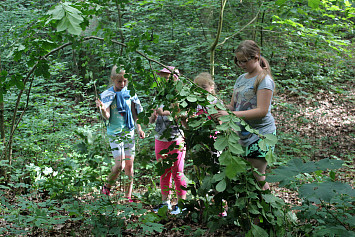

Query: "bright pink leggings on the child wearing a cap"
<box><xmin>155</xmin><ymin>138</ymin><xmax>186</xmax><ymax>196</ymax></box>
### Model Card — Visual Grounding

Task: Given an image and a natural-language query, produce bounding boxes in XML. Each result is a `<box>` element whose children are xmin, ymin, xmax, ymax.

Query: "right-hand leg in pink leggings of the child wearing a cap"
<box><xmin>172</xmin><ymin>139</ymin><xmax>186</xmax><ymax>199</ymax></box>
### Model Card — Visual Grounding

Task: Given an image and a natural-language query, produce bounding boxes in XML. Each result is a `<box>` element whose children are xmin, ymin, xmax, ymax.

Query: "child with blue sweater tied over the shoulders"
<box><xmin>96</xmin><ymin>66</ymin><xmax>145</xmax><ymax>202</ymax></box>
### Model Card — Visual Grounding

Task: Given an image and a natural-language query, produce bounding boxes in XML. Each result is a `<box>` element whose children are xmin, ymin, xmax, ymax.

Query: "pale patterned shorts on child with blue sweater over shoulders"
<box><xmin>110</xmin><ymin>129</ymin><xmax>135</xmax><ymax>158</ymax></box>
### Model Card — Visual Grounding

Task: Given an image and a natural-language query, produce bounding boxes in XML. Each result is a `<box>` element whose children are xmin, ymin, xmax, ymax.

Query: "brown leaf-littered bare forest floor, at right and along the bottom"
<box><xmin>0</xmin><ymin>88</ymin><xmax>355</xmax><ymax>237</ymax></box>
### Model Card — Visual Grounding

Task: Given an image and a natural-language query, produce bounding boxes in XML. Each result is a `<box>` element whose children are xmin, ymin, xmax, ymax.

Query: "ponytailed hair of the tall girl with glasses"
<box><xmin>234</xmin><ymin>40</ymin><xmax>272</xmax><ymax>94</ymax></box>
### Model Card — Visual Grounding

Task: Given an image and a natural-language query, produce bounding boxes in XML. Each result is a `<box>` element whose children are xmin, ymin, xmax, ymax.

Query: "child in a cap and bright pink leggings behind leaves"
<box><xmin>149</xmin><ymin>67</ymin><xmax>186</xmax><ymax>214</ymax></box>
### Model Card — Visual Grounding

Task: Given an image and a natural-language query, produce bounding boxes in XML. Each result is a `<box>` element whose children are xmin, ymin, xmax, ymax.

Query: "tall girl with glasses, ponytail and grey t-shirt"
<box><xmin>216</xmin><ymin>40</ymin><xmax>276</xmax><ymax>190</ymax></box>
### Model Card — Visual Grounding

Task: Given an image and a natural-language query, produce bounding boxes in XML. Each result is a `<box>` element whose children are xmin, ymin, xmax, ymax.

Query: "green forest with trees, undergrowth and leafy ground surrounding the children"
<box><xmin>0</xmin><ymin>0</ymin><xmax>355</xmax><ymax>237</ymax></box>
